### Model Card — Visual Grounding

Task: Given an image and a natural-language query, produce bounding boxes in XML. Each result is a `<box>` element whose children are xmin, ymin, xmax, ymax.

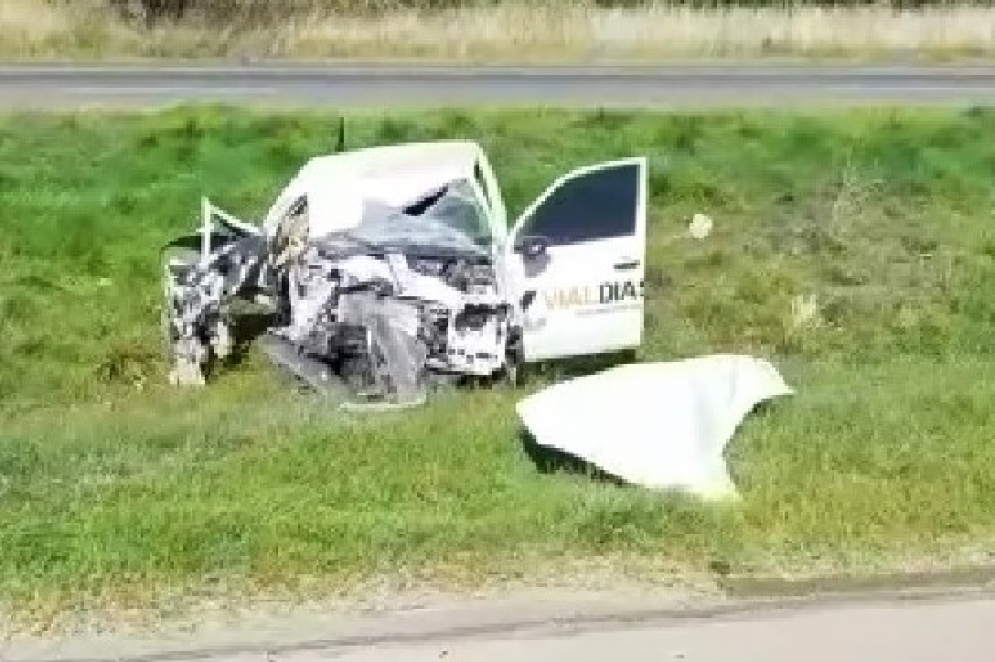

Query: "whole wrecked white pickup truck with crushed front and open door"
<box><xmin>163</xmin><ymin>141</ymin><xmax>647</xmax><ymax>404</ymax></box>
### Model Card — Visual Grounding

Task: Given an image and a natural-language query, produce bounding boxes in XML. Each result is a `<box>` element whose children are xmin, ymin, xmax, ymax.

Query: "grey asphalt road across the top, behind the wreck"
<box><xmin>0</xmin><ymin>64</ymin><xmax>995</xmax><ymax>108</ymax></box>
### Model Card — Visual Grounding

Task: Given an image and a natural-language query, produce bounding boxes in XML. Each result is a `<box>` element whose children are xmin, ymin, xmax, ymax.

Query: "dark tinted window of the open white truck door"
<box><xmin>522</xmin><ymin>164</ymin><xmax>640</xmax><ymax>246</ymax></box>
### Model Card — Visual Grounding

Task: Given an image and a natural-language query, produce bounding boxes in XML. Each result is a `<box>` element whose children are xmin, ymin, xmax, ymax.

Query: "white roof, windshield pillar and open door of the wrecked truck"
<box><xmin>234</xmin><ymin>140</ymin><xmax>647</xmax><ymax>362</ymax></box>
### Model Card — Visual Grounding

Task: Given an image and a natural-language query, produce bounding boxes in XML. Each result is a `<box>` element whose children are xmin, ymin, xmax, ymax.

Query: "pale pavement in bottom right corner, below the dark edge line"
<box><xmin>322</xmin><ymin>602</ymin><xmax>995</xmax><ymax>662</ymax></box>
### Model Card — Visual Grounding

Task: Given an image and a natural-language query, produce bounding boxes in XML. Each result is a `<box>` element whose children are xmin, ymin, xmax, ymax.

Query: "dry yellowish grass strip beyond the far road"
<box><xmin>0</xmin><ymin>0</ymin><xmax>995</xmax><ymax>62</ymax></box>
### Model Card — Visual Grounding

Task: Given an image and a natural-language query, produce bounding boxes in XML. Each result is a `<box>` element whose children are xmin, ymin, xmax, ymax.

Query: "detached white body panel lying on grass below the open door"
<box><xmin>516</xmin><ymin>354</ymin><xmax>793</xmax><ymax>500</ymax></box>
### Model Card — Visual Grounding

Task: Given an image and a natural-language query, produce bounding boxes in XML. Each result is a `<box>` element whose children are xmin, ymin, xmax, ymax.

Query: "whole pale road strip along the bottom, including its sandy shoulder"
<box><xmin>7</xmin><ymin>592</ymin><xmax>995</xmax><ymax>662</ymax></box>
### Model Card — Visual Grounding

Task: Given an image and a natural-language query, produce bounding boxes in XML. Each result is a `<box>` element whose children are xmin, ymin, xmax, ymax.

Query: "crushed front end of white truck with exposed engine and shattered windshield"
<box><xmin>164</xmin><ymin>182</ymin><xmax>520</xmax><ymax>404</ymax></box>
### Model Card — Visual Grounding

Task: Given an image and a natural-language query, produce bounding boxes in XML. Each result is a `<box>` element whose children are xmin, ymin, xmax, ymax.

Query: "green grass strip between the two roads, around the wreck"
<box><xmin>0</xmin><ymin>108</ymin><xmax>995</xmax><ymax>614</ymax></box>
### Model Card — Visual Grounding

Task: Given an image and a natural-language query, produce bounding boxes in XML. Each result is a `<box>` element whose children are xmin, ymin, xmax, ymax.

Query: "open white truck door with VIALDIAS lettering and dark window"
<box><xmin>506</xmin><ymin>157</ymin><xmax>647</xmax><ymax>362</ymax></box>
